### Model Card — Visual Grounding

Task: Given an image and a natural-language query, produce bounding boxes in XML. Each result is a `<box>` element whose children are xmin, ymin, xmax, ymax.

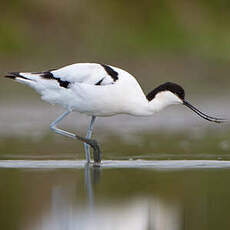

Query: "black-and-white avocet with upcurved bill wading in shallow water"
<box><xmin>5</xmin><ymin>63</ymin><xmax>225</xmax><ymax>164</ymax></box>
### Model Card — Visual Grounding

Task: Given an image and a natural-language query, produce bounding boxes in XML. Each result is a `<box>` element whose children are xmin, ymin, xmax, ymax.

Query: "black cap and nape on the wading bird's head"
<box><xmin>146</xmin><ymin>82</ymin><xmax>185</xmax><ymax>101</ymax></box>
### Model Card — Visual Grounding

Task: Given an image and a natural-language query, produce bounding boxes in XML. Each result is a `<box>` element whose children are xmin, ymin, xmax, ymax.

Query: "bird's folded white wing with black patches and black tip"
<box><xmin>6</xmin><ymin>63</ymin><xmax>119</xmax><ymax>88</ymax></box>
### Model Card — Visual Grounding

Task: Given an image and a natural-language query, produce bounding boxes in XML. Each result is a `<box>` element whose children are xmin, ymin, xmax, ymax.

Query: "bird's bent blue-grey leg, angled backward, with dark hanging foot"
<box><xmin>50</xmin><ymin>110</ymin><xmax>101</xmax><ymax>163</ymax></box>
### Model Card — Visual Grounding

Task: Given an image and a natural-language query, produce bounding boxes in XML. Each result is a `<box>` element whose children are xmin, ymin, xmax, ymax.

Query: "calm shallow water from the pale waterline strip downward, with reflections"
<box><xmin>0</xmin><ymin>160</ymin><xmax>230</xmax><ymax>230</ymax></box>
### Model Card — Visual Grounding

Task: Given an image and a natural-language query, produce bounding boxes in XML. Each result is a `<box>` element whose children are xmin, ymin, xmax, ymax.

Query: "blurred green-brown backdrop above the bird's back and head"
<box><xmin>0</xmin><ymin>0</ymin><xmax>230</xmax><ymax>94</ymax></box>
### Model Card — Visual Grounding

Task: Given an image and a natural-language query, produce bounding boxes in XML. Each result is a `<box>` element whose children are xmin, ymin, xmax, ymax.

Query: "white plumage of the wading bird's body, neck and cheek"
<box><xmin>16</xmin><ymin>63</ymin><xmax>181</xmax><ymax>116</ymax></box>
